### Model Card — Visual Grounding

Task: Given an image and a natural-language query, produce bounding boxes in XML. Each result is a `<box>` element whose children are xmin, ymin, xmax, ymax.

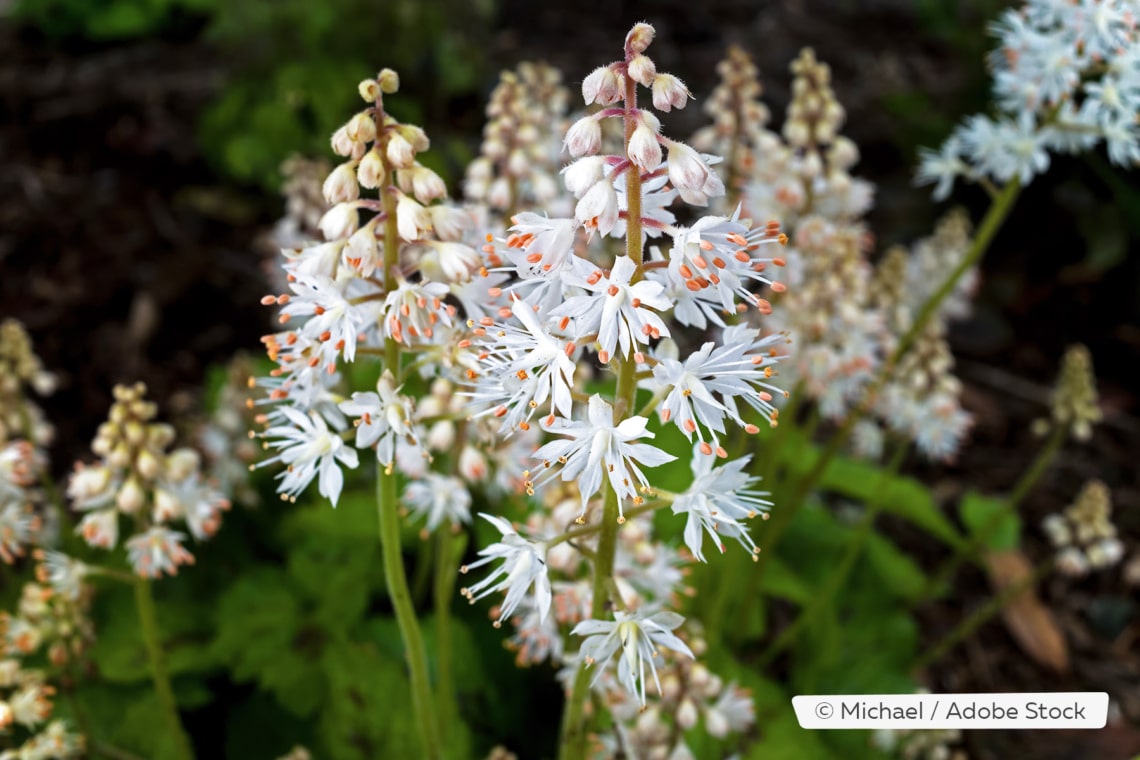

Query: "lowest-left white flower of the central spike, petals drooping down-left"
<box><xmin>459</xmin><ymin>512</ymin><xmax>552</xmax><ymax>628</ymax></box>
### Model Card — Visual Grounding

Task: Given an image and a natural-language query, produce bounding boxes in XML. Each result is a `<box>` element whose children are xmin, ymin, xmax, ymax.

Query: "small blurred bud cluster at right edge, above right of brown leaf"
<box><xmin>1042</xmin><ymin>481</ymin><xmax>1124</xmax><ymax>577</ymax></box>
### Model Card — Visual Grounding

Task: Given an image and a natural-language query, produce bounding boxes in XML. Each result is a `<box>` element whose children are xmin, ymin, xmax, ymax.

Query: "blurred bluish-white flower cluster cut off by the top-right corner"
<box><xmin>917</xmin><ymin>0</ymin><xmax>1140</xmax><ymax>199</ymax></box>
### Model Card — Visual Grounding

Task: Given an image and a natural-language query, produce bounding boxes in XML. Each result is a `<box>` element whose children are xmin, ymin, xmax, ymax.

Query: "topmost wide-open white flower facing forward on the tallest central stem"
<box><xmin>551</xmin><ymin>256</ymin><xmax>673</xmax><ymax>363</ymax></box>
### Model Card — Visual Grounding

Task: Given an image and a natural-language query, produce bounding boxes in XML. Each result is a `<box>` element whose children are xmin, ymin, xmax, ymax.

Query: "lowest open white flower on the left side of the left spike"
<box><xmin>259</xmin><ymin>407</ymin><xmax>359</xmax><ymax>507</ymax></box>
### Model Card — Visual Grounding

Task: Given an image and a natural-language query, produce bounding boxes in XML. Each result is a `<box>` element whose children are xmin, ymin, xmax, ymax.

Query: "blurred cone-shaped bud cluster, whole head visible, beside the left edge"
<box><xmin>67</xmin><ymin>383</ymin><xmax>229</xmax><ymax>578</ymax></box>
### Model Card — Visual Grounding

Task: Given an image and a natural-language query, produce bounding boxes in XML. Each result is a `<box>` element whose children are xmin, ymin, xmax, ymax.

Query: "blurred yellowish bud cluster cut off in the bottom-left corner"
<box><xmin>0</xmin><ymin>583</ymin><xmax>90</xmax><ymax>760</ymax></box>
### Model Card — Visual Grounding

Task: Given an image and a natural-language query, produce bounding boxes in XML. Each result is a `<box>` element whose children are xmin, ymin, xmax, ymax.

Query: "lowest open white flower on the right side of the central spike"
<box><xmin>673</xmin><ymin>451</ymin><xmax>772</xmax><ymax>562</ymax></box>
